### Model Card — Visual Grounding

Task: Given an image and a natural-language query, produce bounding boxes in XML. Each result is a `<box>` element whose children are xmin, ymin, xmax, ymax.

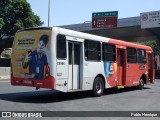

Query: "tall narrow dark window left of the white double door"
<box><xmin>57</xmin><ymin>35</ymin><xmax>67</xmax><ymax>59</ymax></box>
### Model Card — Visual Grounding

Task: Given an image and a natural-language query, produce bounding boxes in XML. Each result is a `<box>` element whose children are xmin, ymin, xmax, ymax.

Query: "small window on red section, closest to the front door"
<box><xmin>138</xmin><ymin>49</ymin><xmax>146</xmax><ymax>63</ymax></box>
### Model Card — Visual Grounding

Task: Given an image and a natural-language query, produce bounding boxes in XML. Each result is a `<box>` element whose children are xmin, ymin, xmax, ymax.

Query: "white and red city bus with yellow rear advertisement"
<box><xmin>11</xmin><ymin>27</ymin><xmax>155</xmax><ymax>96</ymax></box>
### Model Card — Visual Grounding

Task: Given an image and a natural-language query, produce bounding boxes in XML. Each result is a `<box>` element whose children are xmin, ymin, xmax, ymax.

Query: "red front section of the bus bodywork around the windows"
<box><xmin>106</xmin><ymin>39</ymin><xmax>155</xmax><ymax>87</ymax></box>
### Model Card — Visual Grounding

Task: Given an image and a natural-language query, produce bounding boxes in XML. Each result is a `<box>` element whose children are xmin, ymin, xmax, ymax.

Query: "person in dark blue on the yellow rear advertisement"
<box><xmin>23</xmin><ymin>35</ymin><xmax>49</xmax><ymax>79</ymax></box>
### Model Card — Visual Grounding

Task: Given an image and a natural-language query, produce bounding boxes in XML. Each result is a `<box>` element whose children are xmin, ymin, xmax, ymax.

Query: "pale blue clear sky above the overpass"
<box><xmin>27</xmin><ymin>0</ymin><xmax>160</xmax><ymax>26</ymax></box>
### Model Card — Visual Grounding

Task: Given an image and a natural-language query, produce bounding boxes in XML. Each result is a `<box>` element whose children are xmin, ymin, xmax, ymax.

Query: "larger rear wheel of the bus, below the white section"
<box><xmin>93</xmin><ymin>77</ymin><xmax>104</xmax><ymax>97</ymax></box>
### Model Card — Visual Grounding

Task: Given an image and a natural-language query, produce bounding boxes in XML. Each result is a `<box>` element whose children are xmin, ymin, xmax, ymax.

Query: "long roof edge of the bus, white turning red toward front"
<box><xmin>18</xmin><ymin>27</ymin><xmax>152</xmax><ymax>50</ymax></box>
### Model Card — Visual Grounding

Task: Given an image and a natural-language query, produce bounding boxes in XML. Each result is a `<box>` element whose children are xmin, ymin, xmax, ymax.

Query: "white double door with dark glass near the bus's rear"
<box><xmin>68</xmin><ymin>41</ymin><xmax>81</xmax><ymax>90</ymax></box>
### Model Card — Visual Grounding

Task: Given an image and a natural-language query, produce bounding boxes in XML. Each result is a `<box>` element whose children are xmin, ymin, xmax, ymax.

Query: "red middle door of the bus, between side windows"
<box><xmin>117</xmin><ymin>48</ymin><xmax>126</xmax><ymax>86</ymax></box>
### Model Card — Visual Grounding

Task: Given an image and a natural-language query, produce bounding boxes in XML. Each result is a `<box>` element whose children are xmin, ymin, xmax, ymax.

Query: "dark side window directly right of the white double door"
<box><xmin>84</xmin><ymin>40</ymin><xmax>101</xmax><ymax>61</ymax></box>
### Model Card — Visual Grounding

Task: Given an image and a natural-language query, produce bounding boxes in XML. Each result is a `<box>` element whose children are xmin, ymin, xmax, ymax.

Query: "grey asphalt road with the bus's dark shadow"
<box><xmin>0</xmin><ymin>79</ymin><xmax>160</xmax><ymax>120</ymax></box>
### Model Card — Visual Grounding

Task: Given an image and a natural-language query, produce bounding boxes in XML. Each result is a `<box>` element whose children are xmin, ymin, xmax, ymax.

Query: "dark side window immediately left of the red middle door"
<box><xmin>102</xmin><ymin>43</ymin><xmax>116</xmax><ymax>61</ymax></box>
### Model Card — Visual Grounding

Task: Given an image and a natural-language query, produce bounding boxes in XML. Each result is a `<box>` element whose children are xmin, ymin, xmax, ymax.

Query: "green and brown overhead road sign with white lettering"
<box><xmin>92</xmin><ymin>11</ymin><xmax>118</xmax><ymax>28</ymax></box>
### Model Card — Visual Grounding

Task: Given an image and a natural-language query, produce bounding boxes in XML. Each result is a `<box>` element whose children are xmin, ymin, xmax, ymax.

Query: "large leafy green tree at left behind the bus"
<box><xmin>0</xmin><ymin>0</ymin><xmax>43</xmax><ymax>39</ymax></box>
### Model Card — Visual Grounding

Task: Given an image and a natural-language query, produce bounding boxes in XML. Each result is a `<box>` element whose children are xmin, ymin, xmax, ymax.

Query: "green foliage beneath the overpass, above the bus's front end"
<box><xmin>136</xmin><ymin>41</ymin><xmax>159</xmax><ymax>55</ymax></box>
